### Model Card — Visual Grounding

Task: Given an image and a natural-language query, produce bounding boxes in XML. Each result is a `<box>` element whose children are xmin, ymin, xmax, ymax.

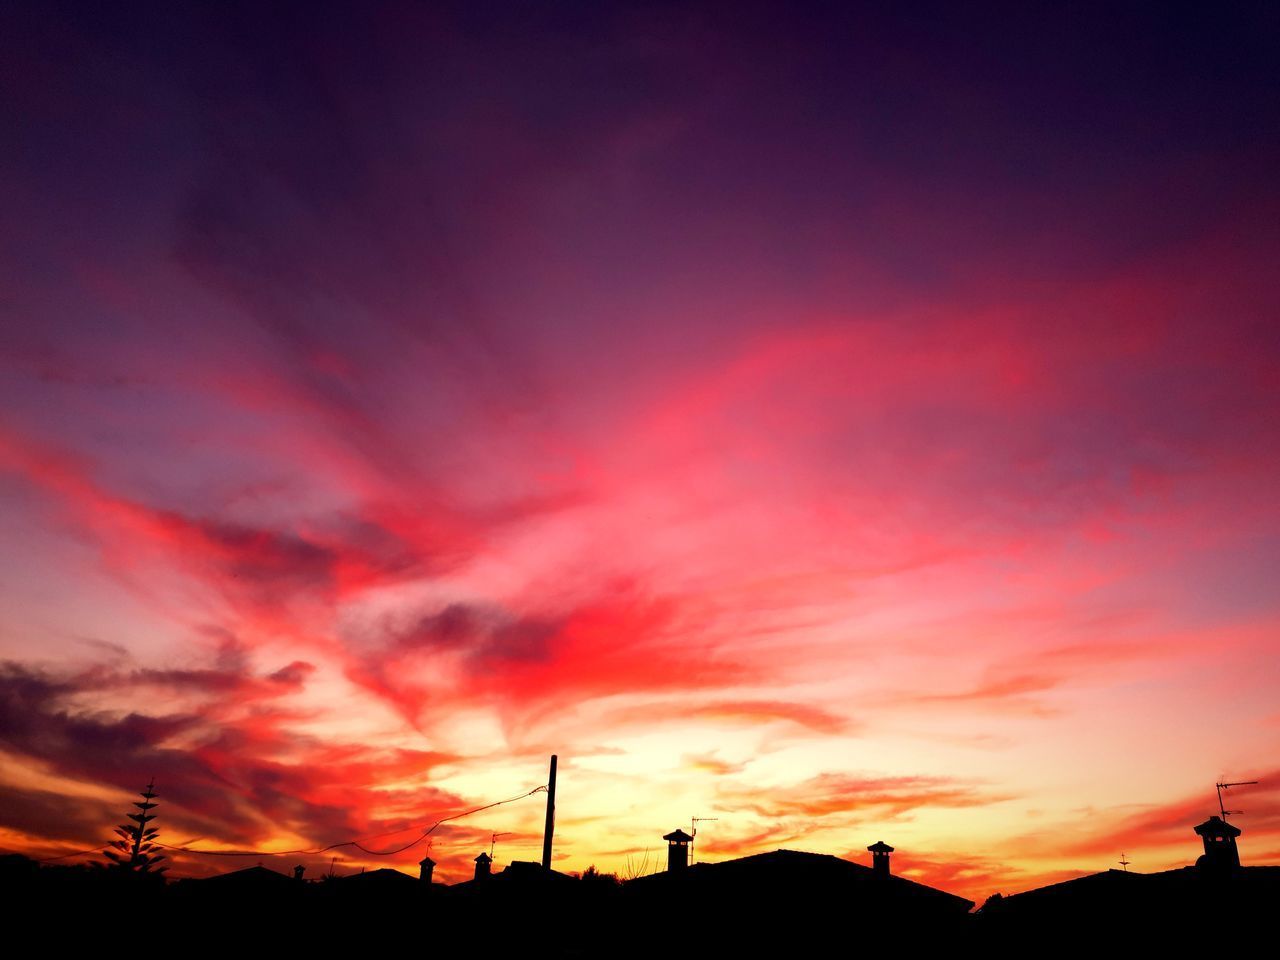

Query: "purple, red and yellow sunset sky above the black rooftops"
<box><xmin>0</xmin><ymin>3</ymin><xmax>1280</xmax><ymax>902</ymax></box>
